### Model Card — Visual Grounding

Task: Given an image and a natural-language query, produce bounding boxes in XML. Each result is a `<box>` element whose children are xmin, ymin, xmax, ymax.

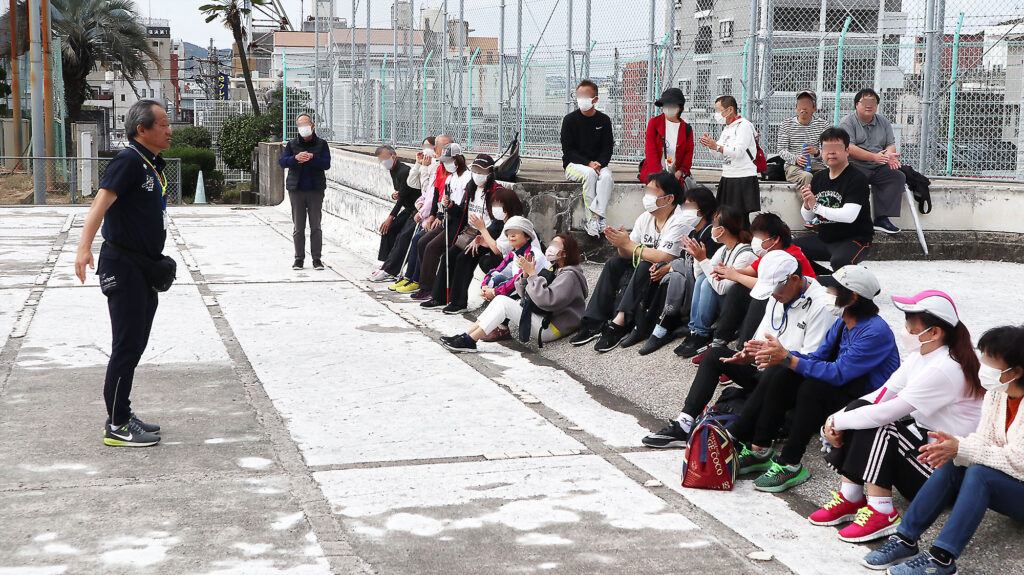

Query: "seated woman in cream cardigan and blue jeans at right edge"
<box><xmin>864</xmin><ymin>325</ymin><xmax>1024</xmax><ymax>575</ymax></box>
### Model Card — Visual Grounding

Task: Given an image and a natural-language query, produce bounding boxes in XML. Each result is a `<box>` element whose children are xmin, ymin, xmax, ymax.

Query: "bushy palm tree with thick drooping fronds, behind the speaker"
<box><xmin>50</xmin><ymin>0</ymin><xmax>163</xmax><ymax>122</ymax></box>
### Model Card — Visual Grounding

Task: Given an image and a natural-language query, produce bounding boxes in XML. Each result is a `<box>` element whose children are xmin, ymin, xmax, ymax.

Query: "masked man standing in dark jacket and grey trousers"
<box><xmin>280</xmin><ymin>114</ymin><xmax>331</xmax><ymax>269</ymax></box>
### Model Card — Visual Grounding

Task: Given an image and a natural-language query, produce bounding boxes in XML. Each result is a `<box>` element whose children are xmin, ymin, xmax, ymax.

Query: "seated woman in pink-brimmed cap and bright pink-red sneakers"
<box><xmin>810</xmin><ymin>291</ymin><xmax>985</xmax><ymax>542</ymax></box>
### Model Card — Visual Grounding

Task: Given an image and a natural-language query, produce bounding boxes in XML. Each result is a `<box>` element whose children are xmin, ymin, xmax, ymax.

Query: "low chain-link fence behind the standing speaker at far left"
<box><xmin>0</xmin><ymin>157</ymin><xmax>182</xmax><ymax>205</ymax></box>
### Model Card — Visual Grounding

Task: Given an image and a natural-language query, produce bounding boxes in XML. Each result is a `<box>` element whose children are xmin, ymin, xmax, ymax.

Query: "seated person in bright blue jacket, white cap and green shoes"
<box><xmin>729</xmin><ymin>265</ymin><xmax>899</xmax><ymax>493</ymax></box>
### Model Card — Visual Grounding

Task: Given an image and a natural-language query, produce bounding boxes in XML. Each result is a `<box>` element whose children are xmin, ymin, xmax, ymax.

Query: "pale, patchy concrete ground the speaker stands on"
<box><xmin>0</xmin><ymin>207</ymin><xmax>1024</xmax><ymax>574</ymax></box>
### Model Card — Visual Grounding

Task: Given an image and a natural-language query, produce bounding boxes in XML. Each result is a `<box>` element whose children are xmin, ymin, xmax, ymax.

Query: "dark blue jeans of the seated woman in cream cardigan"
<box><xmin>898</xmin><ymin>461</ymin><xmax>1024</xmax><ymax>557</ymax></box>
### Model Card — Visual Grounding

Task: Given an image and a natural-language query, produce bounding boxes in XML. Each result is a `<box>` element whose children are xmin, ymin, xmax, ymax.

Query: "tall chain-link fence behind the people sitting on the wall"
<box><xmin>271</xmin><ymin>0</ymin><xmax>1024</xmax><ymax>179</ymax></box>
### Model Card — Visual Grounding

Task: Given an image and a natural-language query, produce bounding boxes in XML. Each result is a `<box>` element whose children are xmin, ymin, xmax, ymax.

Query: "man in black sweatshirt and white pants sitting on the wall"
<box><xmin>561</xmin><ymin>80</ymin><xmax>615</xmax><ymax>236</ymax></box>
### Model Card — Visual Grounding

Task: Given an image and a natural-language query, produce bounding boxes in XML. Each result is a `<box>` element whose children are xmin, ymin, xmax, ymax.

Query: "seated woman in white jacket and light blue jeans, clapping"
<box><xmin>682</xmin><ymin>201</ymin><xmax>757</xmax><ymax>351</ymax></box>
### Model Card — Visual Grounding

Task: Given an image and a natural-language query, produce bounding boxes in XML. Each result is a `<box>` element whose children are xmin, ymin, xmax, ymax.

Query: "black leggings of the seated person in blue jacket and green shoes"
<box><xmin>729</xmin><ymin>368</ymin><xmax>865</xmax><ymax>466</ymax></box>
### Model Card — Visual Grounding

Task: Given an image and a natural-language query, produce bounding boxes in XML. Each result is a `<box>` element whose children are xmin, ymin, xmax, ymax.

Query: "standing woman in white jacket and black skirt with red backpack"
<box><xmin>699</xmin><ymin>96</ymin><xmax>761</xmax><ymax>229</ymax></box>
